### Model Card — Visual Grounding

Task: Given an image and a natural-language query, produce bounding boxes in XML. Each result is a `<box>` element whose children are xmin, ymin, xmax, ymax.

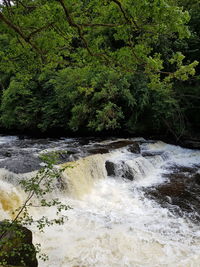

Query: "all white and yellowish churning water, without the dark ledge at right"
<box><xmin>0</xmin><ymin>138</ymin><xmax>200</xmax><ymax>267</ymax></box>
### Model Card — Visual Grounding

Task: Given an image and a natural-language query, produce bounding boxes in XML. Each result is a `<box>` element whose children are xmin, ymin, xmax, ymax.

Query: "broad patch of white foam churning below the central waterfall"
<box><xmin>32</xmin><ymin>179</ymin><xmax>200</xmax><ymax>267</ymax></box>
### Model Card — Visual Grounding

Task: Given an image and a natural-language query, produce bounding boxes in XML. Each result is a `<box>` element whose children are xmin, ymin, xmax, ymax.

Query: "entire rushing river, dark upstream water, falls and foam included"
<box><xmin>0</xmin><ymin>136</ymin><xmax>200</xmax><ymax>267</ymax></box>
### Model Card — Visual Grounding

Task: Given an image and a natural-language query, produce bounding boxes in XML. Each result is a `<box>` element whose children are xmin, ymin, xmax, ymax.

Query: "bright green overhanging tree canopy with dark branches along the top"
<box><xmin>0</xmin><ymin>0</ymin><xmax>196</xmax><ymax>77</ymax></box>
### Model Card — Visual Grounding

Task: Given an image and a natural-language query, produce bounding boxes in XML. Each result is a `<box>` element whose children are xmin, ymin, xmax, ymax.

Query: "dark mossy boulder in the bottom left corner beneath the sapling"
<box><xmin>0</xmin><ymin>221</ymin><xmax>38</xmax><ymax>267</ymax></box>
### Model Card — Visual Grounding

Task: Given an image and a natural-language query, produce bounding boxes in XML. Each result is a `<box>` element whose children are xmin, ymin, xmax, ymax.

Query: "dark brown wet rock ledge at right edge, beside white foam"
<box><xmin>146</xmin><ymin>165</ymin><xmax>200</xmax><ymax>223</ymax></box>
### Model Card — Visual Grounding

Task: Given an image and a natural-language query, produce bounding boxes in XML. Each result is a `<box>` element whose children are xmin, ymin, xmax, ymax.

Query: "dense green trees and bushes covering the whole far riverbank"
<box><xmin>0</xmin><ymin>0</ymin><xmax>200</xmax><ymax>139</ymax></box>
